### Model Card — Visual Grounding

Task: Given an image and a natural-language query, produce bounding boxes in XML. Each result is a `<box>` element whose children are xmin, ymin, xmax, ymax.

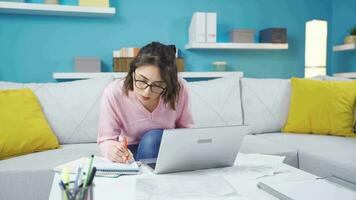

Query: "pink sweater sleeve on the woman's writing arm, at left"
<box><xmin>97</xmin><ymin>85</ymin><xmax>122</xmax><ymax>157</ymax></box>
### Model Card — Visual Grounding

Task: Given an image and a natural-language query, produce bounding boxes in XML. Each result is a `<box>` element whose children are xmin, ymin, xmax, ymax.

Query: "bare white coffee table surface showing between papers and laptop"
<box><xmin>49</xmin><ymin>161</ymin><xmax>317</xmax><ymax>200</ymax></box>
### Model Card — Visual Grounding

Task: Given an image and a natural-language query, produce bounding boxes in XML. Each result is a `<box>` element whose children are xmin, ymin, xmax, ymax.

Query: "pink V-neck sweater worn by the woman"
<box><xmin>98</xmin><ymin>79</ymin><xmax>193</xmax><ymax>156</ymax></box>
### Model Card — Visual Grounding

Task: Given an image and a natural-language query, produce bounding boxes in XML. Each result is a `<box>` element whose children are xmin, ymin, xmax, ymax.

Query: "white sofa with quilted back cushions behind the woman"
<box><xmin>0</xmin><ymin>74</ymin><xmax>356</xmax><ymax>200</ymax></box>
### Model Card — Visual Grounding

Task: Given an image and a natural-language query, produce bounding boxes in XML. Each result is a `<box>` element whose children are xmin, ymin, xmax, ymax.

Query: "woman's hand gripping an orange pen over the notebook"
<box><xmin>107</xmin><ymin>140</ymin><xmax>133</xmax><ymax>163</ymax></box>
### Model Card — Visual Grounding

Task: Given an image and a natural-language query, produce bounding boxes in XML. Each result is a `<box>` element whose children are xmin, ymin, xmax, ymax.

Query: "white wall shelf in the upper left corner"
<box><xmin>0</xmin><ymin>1</ymin><xmax>116</xmax><ymax>17</ymax></box>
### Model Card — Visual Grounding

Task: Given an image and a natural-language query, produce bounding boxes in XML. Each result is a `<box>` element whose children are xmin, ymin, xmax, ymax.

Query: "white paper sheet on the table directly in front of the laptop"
<box><xmin>135</xmin><ymin>175</ymin><xmax>245</xmax><ymax>200</ymax></box>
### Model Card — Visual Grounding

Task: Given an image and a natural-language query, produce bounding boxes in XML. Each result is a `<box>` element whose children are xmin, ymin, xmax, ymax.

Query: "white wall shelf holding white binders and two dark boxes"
<box><xmin>185</xmin><ymin>43</ymin><xmax>288</xmax><ymax>50</ymax></box>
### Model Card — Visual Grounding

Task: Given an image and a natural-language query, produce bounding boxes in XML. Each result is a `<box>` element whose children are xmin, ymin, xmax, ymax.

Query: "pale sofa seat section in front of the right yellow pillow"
<box><xmin>258</xmin><ymin>133</ymin><xmax>356</xmax><ymax>183</ymax></box>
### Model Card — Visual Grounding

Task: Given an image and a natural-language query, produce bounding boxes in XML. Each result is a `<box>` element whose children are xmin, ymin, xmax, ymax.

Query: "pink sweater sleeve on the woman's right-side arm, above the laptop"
<box><xmin>176</xmin><ymin>79</ymin><xmax>194</xmax><ymax>128</ymax></box>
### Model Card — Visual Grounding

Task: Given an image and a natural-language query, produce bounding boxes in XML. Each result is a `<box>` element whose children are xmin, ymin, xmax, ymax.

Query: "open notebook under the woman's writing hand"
<box><xmin>53</xmin><ymin>156</ymin><xmax>140</xmax><ymax>177</ymax></box>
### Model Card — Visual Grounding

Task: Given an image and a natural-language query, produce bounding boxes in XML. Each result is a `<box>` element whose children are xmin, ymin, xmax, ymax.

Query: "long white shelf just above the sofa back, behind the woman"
<box><xmin>53</xmin><ymin>72</ymin><xmax>243</xmax><ymax>80</ymax></box>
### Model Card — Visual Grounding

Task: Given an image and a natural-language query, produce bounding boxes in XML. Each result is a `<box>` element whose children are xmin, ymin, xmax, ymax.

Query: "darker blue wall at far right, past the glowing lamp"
<box><xmin>332</xmin><ymin>0</ymin><xmax>356</xmax><ymax>73</ymax></box>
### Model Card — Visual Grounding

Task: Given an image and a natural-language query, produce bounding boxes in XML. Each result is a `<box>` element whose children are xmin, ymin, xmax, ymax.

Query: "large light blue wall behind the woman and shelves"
<box><xmin>0</xmin><ymin>0</ymin><xmax>330</xmax><ymax>82</ymax></box>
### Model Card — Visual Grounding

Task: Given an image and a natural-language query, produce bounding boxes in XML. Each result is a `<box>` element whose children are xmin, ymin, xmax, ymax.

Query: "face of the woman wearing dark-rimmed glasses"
<box><xmin>133</xmin><ymin>65</ymin><xmax>166</xmax><ymax>105</ymax></box>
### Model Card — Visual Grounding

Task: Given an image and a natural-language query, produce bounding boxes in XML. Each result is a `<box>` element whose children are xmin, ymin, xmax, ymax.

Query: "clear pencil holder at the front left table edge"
<box><xmin>59</xmin><ymin>181</ymin><xmax>95</xmax><ymax>200</ymax></box>
